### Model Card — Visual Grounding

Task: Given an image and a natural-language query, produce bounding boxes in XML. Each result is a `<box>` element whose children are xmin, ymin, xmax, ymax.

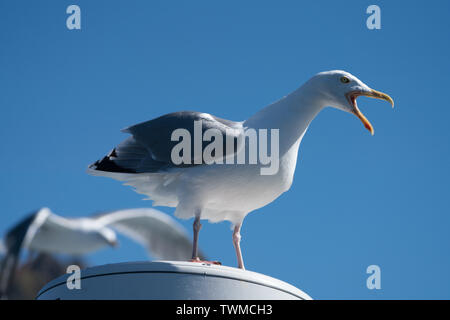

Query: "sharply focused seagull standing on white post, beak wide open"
<box><xmin>88</xmin><ymin>70</ymin><xmax>394</xmax><ymax>269</ymax></box>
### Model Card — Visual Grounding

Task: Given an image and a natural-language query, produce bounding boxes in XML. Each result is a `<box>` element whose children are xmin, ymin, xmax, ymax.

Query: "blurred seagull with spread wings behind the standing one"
<box><xmin>0</xmin><ymin>208</ymin><xmax>199</xmax><ymax>297</ymax></box>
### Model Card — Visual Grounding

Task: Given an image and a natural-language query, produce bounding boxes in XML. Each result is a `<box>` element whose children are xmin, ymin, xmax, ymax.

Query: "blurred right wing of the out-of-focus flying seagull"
<box><xmin>98</xmin><ymin>208</ymin><xmax>203</xmax><ymax>260</ymax></box>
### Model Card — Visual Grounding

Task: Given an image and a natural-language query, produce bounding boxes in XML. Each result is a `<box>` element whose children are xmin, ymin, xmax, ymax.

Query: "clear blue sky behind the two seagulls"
<box><xmin>0</xmin><ymin>0</ymin><xmax>450</xmax><ymax>299</ymax></box>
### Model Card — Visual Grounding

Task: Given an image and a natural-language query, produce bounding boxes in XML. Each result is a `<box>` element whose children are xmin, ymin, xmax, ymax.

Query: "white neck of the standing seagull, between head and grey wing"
<box><xmin>244</xmin><ymin>82</ymin><xmax>326</xmax><ymax>155</ymax></box>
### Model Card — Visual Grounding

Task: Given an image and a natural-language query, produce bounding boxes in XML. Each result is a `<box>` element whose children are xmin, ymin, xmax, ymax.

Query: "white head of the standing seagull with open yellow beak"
<box><xmin>307</xmin><ymin>70</ymin><xmax>394</xmax><ymax>135</ymax></box>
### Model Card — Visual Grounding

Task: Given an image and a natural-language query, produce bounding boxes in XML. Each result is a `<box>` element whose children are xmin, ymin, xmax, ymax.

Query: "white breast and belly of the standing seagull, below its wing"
<box><xmin>171</xmin><ymin>134</ymin><xmax>301</xmax><ymax>222</ymax></box>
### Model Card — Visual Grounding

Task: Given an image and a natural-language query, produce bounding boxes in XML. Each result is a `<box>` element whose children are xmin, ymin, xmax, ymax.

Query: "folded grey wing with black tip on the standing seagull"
<box><xmin>89</xmin><ymin>111</ymin><xmax>243</xmax><ymax>173</ymax></box>
